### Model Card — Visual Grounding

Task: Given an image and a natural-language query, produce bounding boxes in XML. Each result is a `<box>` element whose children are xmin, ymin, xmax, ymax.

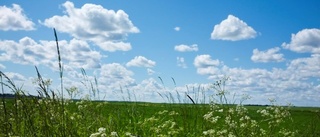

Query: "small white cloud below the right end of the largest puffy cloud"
<box><xmin>126</xmin><ymin>56</ymin><xmax>156</xmax><ymax>68</ymax></box>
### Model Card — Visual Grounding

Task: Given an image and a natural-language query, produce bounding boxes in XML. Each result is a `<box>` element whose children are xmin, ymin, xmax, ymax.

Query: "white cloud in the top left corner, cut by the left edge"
<box><xmin>0</xmin><ymin>4</ymin><xmax>35</xmax><ymax>31</ymax></box>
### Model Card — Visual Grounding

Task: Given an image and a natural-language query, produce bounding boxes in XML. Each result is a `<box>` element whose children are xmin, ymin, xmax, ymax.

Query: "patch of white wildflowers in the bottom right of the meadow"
<box><xmin>203</xmin><ymin>104</ymin><xmax>296</xmax><ymax>137</ymax></box>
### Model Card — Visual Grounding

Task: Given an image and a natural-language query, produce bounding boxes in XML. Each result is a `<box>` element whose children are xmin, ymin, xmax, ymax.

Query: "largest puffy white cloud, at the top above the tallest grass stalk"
<box><xmin>43</xmin><ymin>1</ymin><xmax>139</xmax><ymax>51</ymax></box>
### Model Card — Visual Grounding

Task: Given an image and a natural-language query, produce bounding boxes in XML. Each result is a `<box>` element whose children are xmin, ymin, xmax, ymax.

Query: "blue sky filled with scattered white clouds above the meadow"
<box><xmin>0</xmin><ymin>0</ymin><xmax>320</xmax><ymax>107</ymax></box>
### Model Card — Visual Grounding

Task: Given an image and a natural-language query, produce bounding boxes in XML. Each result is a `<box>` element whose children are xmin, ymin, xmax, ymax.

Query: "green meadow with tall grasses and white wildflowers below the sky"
<box><xmin>0</xmin><ymin>28</ymin><xmax>320</xmax><ymax>137</ymax></box>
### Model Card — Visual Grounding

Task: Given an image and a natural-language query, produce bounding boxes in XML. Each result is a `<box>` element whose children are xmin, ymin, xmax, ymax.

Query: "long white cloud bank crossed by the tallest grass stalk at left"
<box><xmin>0</xmin><ymin>37</ymin><xmax>102</xmax><ymax>70</ymax></box>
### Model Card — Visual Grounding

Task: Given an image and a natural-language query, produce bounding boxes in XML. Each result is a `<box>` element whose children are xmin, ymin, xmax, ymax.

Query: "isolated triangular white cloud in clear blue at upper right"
<box><xmin>211</xmin><ymin>15</ymin><xmax>257</xmax><ymax>41</ymax></box>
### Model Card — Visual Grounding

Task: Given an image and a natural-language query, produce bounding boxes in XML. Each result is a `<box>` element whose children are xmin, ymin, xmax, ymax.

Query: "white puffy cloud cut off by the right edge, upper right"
<box><xmin>282</xmin><ymin>29</ymin><xmax>320</xmax><ymax>53</ymax></box>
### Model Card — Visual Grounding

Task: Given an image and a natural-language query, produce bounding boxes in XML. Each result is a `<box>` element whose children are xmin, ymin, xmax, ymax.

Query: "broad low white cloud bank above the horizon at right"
<box><xmin>194</xmin><ymin>52</ymin><xmax>320</xmax><ymax>104</ymax></box>
